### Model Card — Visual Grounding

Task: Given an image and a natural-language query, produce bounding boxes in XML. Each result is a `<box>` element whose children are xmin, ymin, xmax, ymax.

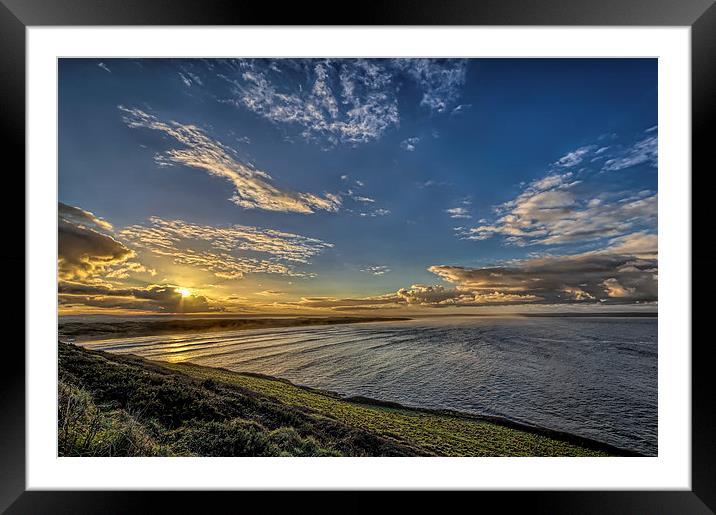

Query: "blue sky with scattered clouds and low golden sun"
<box><xmin>58</xmin><ymin>59</ymin><xmax>658</xmax><ymax>315</ymax></box>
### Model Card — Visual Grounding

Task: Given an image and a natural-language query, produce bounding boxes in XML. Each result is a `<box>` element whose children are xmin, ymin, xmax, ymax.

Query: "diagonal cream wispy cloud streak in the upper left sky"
<box><xmin>119</xmin><ymin>106</ymin><xmax>341</xmax><ymax>214</ymax></box>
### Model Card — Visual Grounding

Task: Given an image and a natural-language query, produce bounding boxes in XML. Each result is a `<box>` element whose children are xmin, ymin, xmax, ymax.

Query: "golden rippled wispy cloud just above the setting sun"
<box><xmin>119</xmin><ymin>217</ymin><xmax>333</xmax><ymax>279</ymax></box>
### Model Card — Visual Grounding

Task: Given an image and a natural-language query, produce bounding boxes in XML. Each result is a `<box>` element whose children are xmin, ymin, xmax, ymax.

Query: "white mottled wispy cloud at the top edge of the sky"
<box><xmin>206</xmin><ymin>59</ymin><xmax>467</xmax><ymax>145</ymax></box>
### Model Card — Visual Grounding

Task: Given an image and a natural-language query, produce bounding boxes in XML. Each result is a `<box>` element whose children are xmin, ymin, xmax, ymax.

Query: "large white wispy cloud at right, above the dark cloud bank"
<box><xmin>457</xmin><ymin>129</ymin><xmax>658</xmax><ymax>246</ymax></box>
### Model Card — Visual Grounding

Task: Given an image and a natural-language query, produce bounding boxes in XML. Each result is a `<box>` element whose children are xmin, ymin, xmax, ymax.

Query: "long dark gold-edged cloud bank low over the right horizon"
<box><xmin>282</xmin><ymin>232</ymin><xmax>658</xmax><ymax>311</ymax></box>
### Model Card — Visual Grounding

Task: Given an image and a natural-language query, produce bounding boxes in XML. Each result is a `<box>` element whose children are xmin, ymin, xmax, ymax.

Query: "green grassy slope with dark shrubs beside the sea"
<box><xmin>60</xmin><ymin>344</ymin><xmax>618</xmax><ymax>456</ymax></box>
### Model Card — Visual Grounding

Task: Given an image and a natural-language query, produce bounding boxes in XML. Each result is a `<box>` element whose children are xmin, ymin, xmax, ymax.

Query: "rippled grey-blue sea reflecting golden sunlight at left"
<box><xmin>84</xmin><ymin>317</ymin><xmax>657</xmax><ymax>455</ymax></box>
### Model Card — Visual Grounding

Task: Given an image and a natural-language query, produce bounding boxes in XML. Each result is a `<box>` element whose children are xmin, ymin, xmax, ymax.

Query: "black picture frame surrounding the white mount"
<box><xmin>0</xmin><ymin>0</ymin><xmax>716</xmax><ymax>514</ymax></box>
